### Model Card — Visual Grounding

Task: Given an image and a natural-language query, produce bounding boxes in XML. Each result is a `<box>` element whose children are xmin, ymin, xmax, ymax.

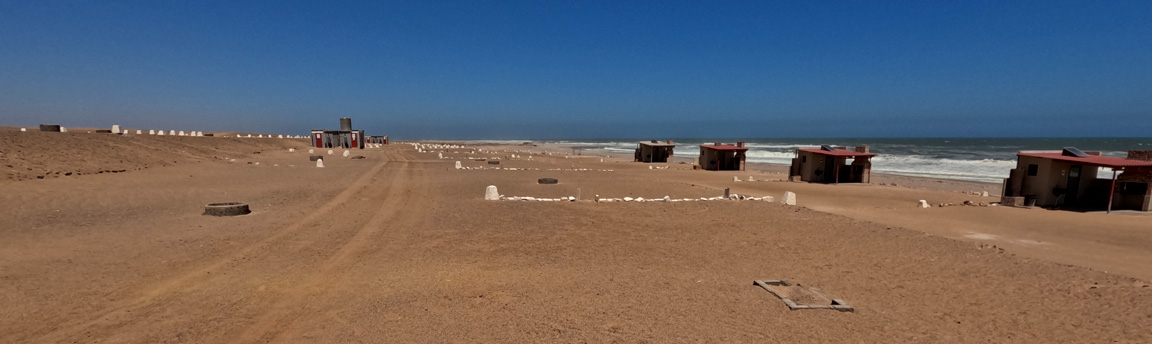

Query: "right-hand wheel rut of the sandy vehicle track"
<box><xmin>236</xmin><ymin>151</ymin><xmax>430</xmax><ymax>343</ymax></box>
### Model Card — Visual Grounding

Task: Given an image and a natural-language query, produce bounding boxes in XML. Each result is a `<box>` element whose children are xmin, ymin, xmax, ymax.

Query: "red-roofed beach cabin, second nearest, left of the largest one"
<box><xmin>788</xmin><ymin>146</ymin><xmax>876</xmax><ymax>184</ymax></box>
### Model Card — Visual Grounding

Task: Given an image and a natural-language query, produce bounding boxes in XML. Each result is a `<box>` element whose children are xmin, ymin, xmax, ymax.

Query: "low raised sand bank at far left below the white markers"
<box><xmin>0</xmin><ymin>130</ymin><xmax>308</xmax><ymax>181</ymax></box>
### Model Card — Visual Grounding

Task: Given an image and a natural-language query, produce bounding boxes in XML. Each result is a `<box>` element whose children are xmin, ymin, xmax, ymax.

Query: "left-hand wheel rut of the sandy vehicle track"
<box><xmin>31</xmin><ymin>155</ymin><xmax>389</xmax><ymax>343</ymax></box>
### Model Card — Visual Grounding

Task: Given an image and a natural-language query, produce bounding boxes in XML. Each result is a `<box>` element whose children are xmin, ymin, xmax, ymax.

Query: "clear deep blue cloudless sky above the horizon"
<box><xmin>0</xmin><ymin>0</ymin><xmax>1152</xmax><ymax>139</ymax></box>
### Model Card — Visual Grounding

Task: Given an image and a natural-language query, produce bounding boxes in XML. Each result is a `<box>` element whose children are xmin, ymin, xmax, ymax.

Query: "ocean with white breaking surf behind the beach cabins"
<box><xmin>552</xmin><ymin>138</ymin><xmax>1152</xmax><ymax>183</ymax></box>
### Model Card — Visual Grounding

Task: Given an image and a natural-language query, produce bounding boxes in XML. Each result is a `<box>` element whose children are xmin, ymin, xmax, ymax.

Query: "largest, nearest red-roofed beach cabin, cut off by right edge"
<box><xmin>1000</xmin><ymin>147</ymin><xmax>1152</xmax><ymax>212</ymax></box>
